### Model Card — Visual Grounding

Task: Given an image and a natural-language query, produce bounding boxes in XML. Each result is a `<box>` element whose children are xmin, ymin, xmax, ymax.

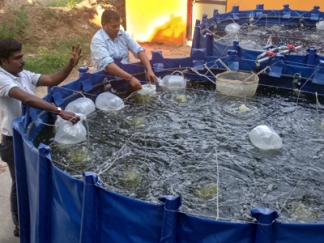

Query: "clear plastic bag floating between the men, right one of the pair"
<box><xmin>95</xmin><ymin>92</ymin><xmax>125</xmax><ymax>111</ymax></box>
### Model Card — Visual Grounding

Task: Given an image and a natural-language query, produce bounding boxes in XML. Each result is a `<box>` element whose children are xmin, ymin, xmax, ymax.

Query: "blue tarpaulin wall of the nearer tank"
<box><xmin>13</xmin><ymin>53</ymin><xmax>324</xmax><ymax>243</ymax></box>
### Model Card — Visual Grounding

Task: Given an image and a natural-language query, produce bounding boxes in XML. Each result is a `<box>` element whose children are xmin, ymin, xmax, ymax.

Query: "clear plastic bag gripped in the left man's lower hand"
<box><xmin>54</xmin><ymin>113</ymin><xmax>87</xmax><ymax>144</ymax></box>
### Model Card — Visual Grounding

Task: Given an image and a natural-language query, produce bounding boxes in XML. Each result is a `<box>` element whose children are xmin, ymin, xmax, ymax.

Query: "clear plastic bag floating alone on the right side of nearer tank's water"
<box><xmin>249</xmin><ymin>125</ymin><xmax>282</xmax><ymax>150</ymax></box>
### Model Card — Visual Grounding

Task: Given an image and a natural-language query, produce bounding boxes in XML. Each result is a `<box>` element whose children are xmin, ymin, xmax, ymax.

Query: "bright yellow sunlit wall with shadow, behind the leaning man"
<box><xmin>126</xmin><ymin>0</ymin><xmax>187</xmax><ymax>45</ymax></box>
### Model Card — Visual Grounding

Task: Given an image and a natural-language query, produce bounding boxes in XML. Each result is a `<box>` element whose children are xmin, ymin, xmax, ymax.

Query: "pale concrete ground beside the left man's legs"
<box><xmin>0</xmin><ymin>160</ymin><xmax>19</xmax><ymax>243</ymax></box>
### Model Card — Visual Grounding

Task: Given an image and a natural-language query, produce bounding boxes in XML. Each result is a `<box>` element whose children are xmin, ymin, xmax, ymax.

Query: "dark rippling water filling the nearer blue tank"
<box><xmin>37</xmin><ymin>85</ymin><xmax>324</xmax><ymax>222</ymax></box>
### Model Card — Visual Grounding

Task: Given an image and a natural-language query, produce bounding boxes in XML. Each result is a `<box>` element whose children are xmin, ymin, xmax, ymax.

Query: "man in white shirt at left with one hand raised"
<box><xmin>0</xmin><ymin>38</ymin><xmax>82</xmax><ymax>236</ymax></box>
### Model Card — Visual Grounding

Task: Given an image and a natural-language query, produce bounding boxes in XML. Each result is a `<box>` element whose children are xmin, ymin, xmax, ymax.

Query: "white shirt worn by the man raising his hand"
<box><xmin>0</xmin><ymin>67</ymin><xmax>41</xmax><ymax>136</ymax></box>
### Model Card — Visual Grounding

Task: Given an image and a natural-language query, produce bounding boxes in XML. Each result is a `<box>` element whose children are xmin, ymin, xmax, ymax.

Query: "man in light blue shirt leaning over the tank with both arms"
<box><xmin>90</xmin><ymin>9</ymin><xmax>156</xmax><ymax>90</ymax></box>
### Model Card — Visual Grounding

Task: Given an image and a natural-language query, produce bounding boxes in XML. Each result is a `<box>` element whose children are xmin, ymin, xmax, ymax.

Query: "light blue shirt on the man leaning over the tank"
<box><xmin>90</xmin><ymin>29</ymin><xmax>145</xmax><ymax>71</ymax></box>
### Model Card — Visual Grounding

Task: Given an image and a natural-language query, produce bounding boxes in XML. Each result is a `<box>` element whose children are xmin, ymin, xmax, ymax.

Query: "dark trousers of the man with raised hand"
<box><xmin>0</xmin><ymin>135</ymin><xmax>19</xmax><ymax>225</ymax></box>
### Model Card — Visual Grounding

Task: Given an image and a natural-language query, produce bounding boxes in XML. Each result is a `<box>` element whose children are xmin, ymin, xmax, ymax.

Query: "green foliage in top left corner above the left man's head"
<box><xmin>0</xmin><ymin>5</ymin><xmax>30</xmax><ymax>39</ymax></box>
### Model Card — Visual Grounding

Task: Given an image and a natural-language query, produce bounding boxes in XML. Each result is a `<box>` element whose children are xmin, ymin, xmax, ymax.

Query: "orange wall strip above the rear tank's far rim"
<box><xmin>227</xmin><ymin>0</ymin><xmax>324</xmax><ymax>12</ymax></box>
